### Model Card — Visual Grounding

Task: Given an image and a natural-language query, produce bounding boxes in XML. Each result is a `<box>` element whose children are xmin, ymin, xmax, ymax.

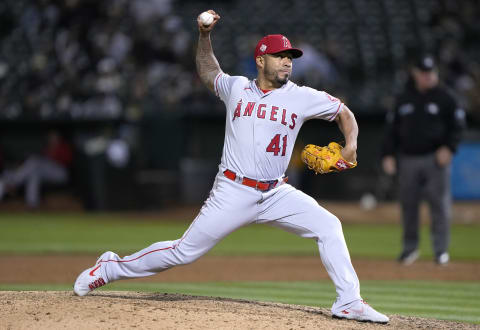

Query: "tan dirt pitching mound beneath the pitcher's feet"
<box><xmin>0</xmin><ymin>291</ymin><xmax>478</xmax><ymax>330</ymax></box>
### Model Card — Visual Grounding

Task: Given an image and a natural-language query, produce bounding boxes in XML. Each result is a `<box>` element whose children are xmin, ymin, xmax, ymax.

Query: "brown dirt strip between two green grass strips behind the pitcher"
<box><xmin>0</xmin><ymin>255</ymin><xmax>480</xmax><ymax>284</ymax></box>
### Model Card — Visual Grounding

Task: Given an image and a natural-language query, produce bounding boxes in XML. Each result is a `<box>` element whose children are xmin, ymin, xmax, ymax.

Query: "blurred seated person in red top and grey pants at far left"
<box><xmin>0</xmin><ymin>131</ymin><xmax>73</xmax><ymax>208</ymax></box>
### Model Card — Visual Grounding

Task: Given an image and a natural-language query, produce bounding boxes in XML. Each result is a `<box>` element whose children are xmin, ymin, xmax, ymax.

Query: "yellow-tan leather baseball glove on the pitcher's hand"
<box><xmin>301</xmin><ymin>142</ymin><xmax>357</xmax><ymax>174</ymax></box>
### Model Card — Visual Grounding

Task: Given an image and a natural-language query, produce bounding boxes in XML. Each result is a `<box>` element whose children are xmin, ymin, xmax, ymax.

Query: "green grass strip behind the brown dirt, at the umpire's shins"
<box><xmin>0</xmin><ymin>214</ymin><xmax>480</xmax><ymax>260</ymax></box>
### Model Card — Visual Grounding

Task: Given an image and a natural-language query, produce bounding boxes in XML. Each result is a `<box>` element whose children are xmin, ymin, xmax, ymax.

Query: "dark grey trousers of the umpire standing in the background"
<box><xmin>399</xmin><ymin>153</ymin><xmax>452</xmax><ymax>256</ymax></box>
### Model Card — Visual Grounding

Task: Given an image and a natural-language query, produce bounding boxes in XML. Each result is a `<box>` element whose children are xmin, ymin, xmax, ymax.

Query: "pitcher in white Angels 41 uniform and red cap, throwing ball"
<box><xmin>74</xmin><ymin>10</ymin><xmax>389</xmax><ymax>323</ymax></box>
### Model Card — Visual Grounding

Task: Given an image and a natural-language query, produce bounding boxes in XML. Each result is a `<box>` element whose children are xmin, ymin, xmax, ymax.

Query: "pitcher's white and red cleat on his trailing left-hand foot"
<box><xmin>73</xmin><ymin>251</ymin><xmax>115</xmax><ymax>296</ymax></box>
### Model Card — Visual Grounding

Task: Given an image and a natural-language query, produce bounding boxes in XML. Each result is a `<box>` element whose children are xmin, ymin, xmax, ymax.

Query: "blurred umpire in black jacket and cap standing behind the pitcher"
<box><xmin>382</xmin><ymin>55</ymin><xmax>465</xmax><ymax>265</ymax></box>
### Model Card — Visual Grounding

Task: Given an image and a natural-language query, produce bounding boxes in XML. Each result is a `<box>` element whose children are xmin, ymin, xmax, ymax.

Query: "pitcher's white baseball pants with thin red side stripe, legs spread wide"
<box><xmin>102</xmin><ymin>172</ymin><xmax>361</xmax><ymax>312</ymax></box>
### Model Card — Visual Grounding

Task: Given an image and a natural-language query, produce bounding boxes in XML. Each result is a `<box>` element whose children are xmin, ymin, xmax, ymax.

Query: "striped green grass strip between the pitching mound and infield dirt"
<box><xmin>0</xmin><ymin>281</ymin><xmax>480</xmax><ymax>324</ymax></box>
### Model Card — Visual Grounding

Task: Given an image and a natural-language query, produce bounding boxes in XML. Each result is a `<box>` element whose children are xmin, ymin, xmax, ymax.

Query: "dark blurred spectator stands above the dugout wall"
<box><xmin>0</xmin><ymin>0</ymin><xmax>480</xmax><ymax>120</ymax></box>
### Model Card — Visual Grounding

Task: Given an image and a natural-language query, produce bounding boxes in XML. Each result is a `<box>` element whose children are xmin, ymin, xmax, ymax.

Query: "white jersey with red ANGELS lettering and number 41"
<box><xmin>214</xmin><ymin>72</ymin><xmax>343</xmax><ymax>180</ymax></box>
